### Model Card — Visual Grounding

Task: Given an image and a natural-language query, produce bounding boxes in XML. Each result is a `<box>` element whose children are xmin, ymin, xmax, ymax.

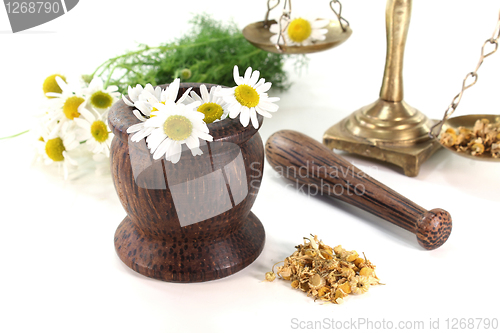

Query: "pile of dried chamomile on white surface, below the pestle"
<box><xmin>266</xmin><ymin>235</ymin><xmax>380</xmax><ymax>304</ymax></box>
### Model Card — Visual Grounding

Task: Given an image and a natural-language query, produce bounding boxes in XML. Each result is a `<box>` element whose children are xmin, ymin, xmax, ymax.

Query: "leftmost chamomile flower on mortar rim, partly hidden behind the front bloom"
<box><xmin>127</xmin><ymin>79</ymin><xmax>191</xmax><ymax>141</ymax></box>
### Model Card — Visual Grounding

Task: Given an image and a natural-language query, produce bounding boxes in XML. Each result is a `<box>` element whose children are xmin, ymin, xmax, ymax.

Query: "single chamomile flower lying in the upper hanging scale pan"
<box><xmin>269</xmin><ymin>17</ymin><xmax>330</xmax><ymax>46</ymax></box>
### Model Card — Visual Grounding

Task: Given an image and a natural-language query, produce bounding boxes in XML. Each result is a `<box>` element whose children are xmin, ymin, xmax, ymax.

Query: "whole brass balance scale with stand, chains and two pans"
<box><xmin>243</xmin><ymin>0</ymin><xmax>500</xmax><ymax>176</ymax></box>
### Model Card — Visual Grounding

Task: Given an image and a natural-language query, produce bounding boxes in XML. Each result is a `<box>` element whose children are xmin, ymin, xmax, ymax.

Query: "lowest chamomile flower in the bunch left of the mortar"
<box><xmin>39</xmin><ymin>123</ymin><xmax>79</xmax><ymax>179</ymax></box>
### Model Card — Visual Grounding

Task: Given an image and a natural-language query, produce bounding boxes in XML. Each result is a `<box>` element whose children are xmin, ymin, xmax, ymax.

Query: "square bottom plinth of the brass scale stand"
<box><xmin>323</xmin><ymin>116</ymin><xmax>441</xmax><ymax>177</ymax></box>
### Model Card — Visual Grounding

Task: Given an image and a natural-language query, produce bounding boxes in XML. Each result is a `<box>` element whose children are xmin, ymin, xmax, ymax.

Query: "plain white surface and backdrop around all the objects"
<box><xmin>0</xmin><ymin>0</ymin><xmax>500</xmax><ymax>332</ymax></box>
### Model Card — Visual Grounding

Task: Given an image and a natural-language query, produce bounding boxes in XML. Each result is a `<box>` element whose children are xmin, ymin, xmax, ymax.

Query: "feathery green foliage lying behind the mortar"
<box><xmin>90</xmin><ymin>14</ymin><xmax>305</xmax><ymax>93</ymax></box>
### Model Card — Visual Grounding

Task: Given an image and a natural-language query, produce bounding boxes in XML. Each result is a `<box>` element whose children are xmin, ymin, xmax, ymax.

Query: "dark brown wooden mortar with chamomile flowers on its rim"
<box><xmin>108</xmin><ymin>83</ymin><xmax>265</xmax><ymax>282</ymax></box>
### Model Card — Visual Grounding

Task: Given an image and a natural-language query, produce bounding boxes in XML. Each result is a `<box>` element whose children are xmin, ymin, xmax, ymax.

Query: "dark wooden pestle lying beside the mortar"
<box><xmin>266</xmin><ymin>130</ymin><xmax>451</xmax><ymax>250</ymax></box>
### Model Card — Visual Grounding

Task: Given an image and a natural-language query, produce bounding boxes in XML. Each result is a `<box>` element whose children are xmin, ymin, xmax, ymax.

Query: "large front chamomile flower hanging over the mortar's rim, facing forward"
<box><xmin>133</xmin><ymin>101</ymin><xmax>213</xmax><ymax>163</ymax></box>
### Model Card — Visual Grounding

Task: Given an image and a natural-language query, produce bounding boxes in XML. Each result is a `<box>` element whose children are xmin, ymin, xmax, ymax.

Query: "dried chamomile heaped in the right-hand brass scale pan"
<box><xmin>440</xmin><ymin>117</ymin><xmax>500</xmax><ymax>158</ymax></box>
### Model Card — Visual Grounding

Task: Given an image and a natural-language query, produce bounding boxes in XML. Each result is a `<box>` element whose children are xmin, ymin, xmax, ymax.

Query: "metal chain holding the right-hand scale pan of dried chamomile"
<box><xmin>429</xmin><ymin>12</ymin><xmax>500</xmax><ymax>139</ymax></box>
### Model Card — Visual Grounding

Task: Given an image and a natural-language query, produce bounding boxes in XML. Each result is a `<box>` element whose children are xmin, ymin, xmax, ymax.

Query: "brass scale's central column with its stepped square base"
<box><xmin>323</xmin><ymin>0</ymin><xmax>441</xmax><ymax>177</ymax></box>
